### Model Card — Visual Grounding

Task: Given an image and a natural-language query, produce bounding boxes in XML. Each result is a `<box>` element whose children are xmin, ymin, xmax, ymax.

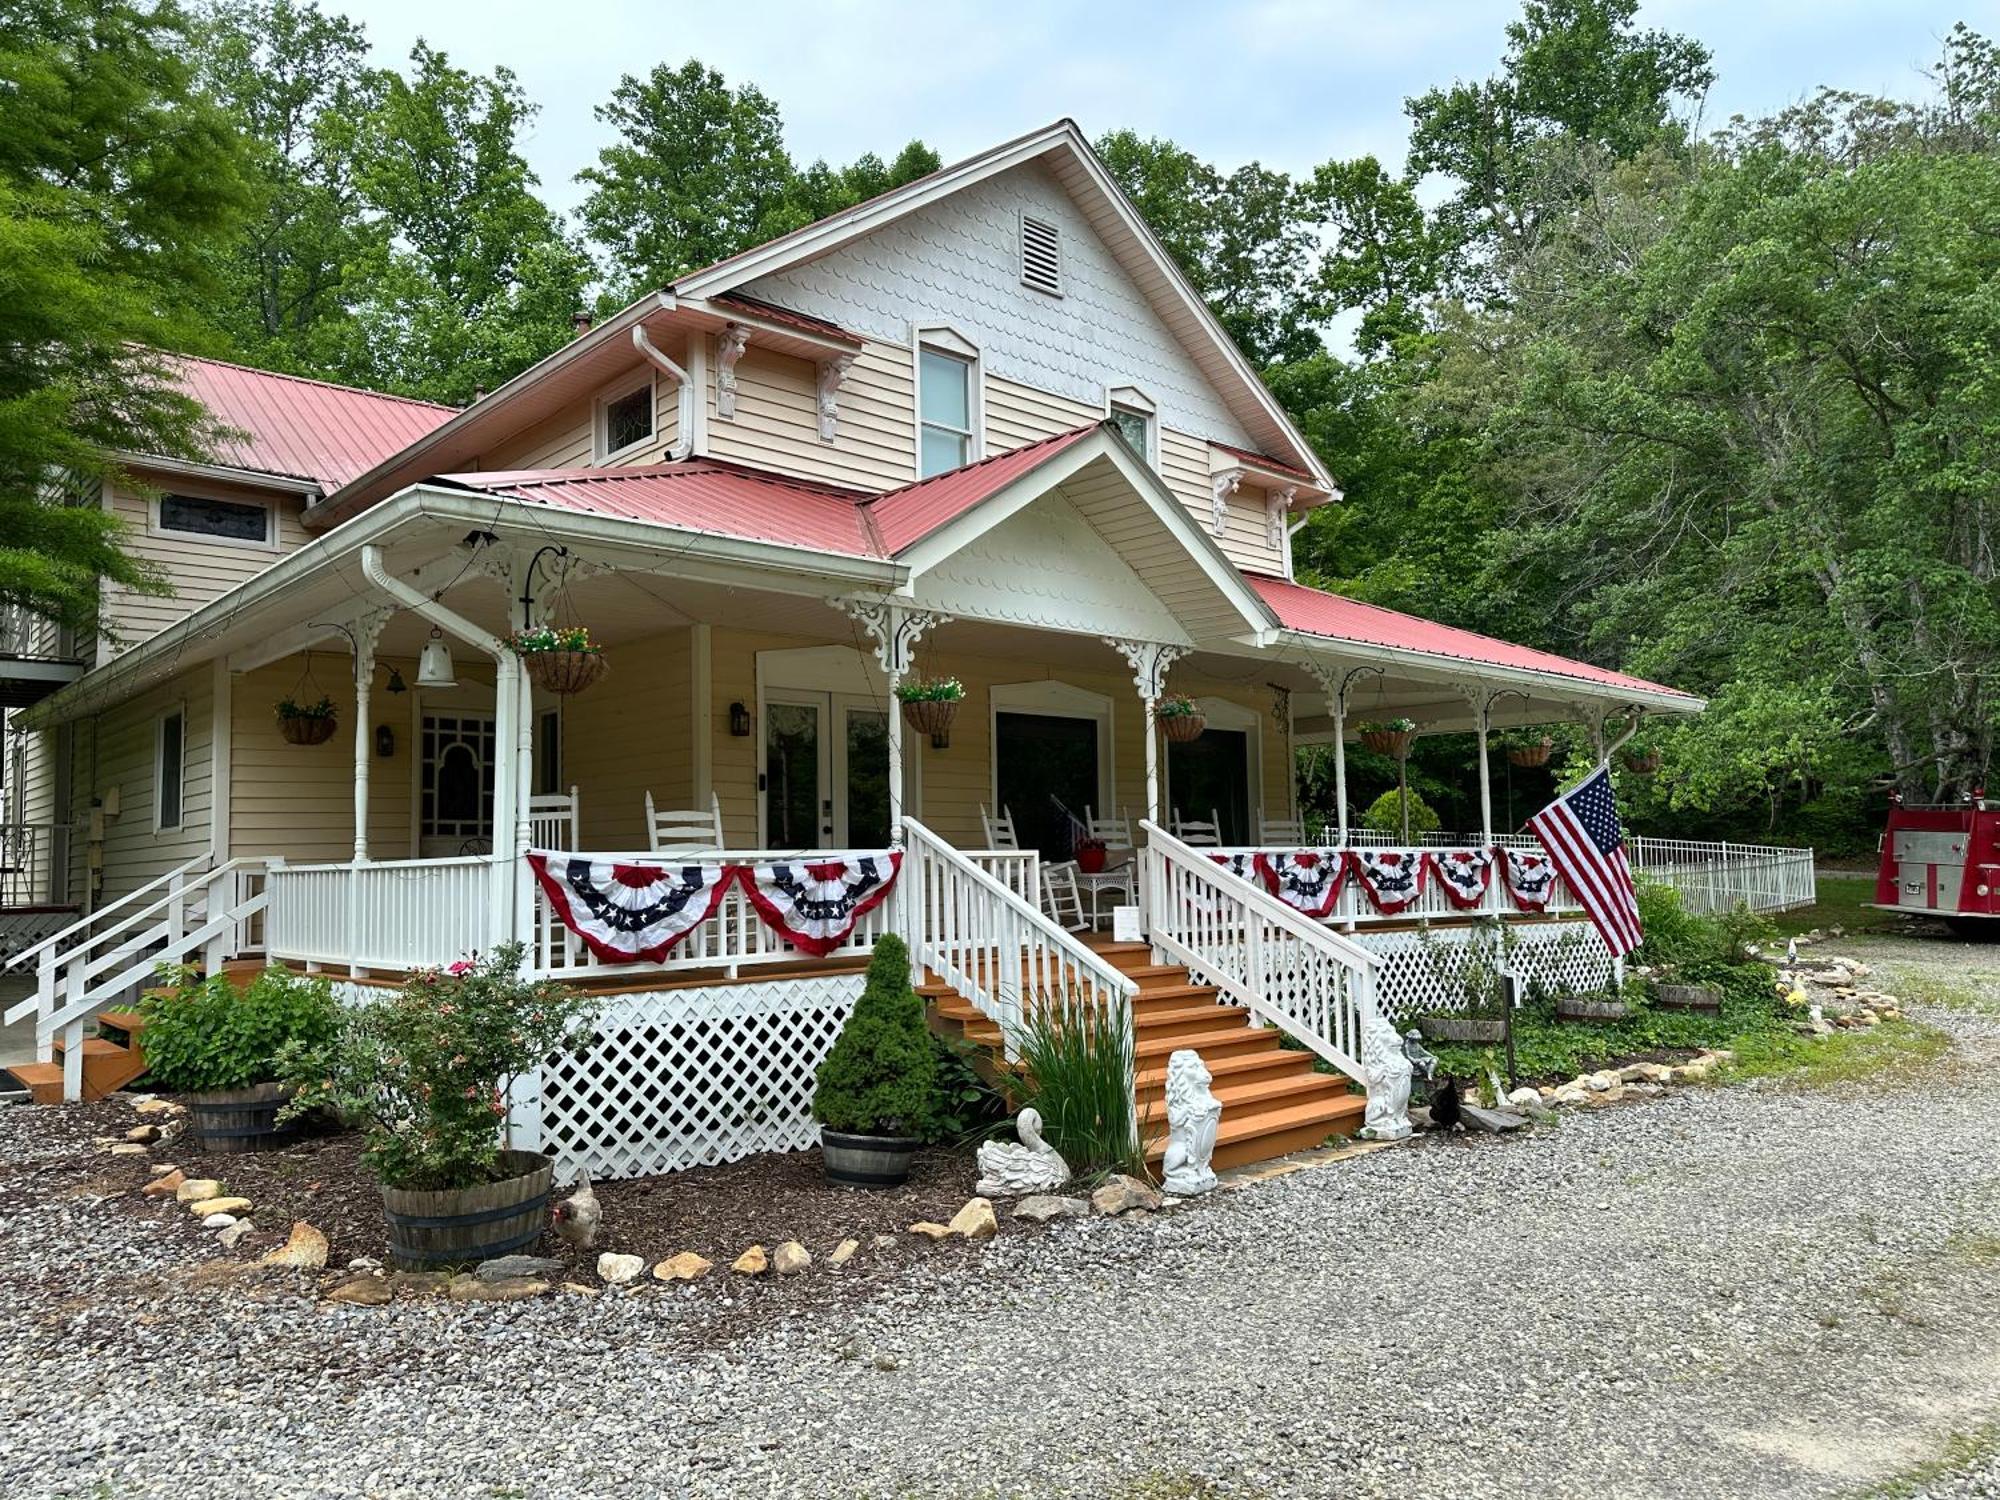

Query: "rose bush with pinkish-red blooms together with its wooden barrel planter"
<box><xmin>280</xmin><ymin>942</ymin><xmax>598</xmax><ymax>1270</ymax></box>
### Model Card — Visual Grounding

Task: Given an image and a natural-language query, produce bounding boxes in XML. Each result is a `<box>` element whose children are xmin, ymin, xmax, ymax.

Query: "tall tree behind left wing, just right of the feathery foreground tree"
<box><xmin>196</xmin><ymin>0</ymin><xmax>388</xmax><ymax>374</ymax></box>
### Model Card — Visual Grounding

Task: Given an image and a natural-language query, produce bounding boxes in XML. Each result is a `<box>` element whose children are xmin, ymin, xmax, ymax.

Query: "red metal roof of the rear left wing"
<box><xmin>170</xmin><ymin>354</ymin><xmax>458</xmax><ymax>490</ymax></box>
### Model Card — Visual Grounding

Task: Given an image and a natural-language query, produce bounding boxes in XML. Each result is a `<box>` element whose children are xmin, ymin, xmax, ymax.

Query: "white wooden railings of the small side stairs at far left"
<box><xmin>4</xmin><ymin>860</ymin><xmax>268</xmax><ymax>1100</ymax></box>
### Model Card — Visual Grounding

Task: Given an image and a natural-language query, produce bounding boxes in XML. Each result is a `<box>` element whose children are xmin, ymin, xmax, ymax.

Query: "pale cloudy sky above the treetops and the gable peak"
<box><xmin>320</xmin><ymin>0</ymin><xmax>1968</xmax><ymax>208</ymax></box>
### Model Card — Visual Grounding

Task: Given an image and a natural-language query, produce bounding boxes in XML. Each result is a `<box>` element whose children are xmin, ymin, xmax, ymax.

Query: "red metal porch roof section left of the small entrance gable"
<box><xmin>440</xmin><ymin>458</ymin><xmax>882</xmax><ymax>558</ymax></box>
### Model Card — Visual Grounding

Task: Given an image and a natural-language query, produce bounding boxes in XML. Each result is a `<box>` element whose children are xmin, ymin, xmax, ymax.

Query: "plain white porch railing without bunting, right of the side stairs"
<box><xmin>264</xmin><ymin>854</ymin><xmax>494</xmax><ymax>972</ymax></box>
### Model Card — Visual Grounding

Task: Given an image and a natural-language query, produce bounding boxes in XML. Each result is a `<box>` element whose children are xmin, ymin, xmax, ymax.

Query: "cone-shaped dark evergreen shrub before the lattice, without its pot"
<box><xmin>812</xmin><ymin>932</ymin><xmax>938</xmax><ymax>1136</ymax></box>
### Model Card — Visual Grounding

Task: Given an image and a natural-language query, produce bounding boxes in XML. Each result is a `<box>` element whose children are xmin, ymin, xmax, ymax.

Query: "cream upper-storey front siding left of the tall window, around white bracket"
<box><xmin>706</xmin><ymin>334</ymin><xmax>916</xmax><ymax>490</ymax></box>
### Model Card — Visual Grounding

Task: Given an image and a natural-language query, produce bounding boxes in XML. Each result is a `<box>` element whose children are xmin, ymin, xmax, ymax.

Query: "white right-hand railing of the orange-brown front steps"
<box><xmin>1140</xmin><ymin>818</ymin><xmax>1382</xmax><ymax>1082</ymax></box>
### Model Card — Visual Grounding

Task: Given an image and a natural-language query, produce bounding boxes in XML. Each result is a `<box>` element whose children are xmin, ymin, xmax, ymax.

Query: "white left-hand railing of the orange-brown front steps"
<box><xmin>896</xmin><ymin>818</ymin><xmax>1138</xmax><ymax>1058</ymax></box>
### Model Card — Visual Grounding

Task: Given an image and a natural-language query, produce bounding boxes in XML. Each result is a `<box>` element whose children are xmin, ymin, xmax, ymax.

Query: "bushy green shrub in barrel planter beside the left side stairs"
<box><xmin>140</xmin><ymin>966</ymin><xmax>340</xmax><ymax>1154</ymax></box>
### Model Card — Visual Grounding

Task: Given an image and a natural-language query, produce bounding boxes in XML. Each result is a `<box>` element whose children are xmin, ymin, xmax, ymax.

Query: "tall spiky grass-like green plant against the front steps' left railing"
<box><xmin>1014</xmin><ymin>1002</ymin><xmax>1136</xmax><ymax>1178</ymax></box>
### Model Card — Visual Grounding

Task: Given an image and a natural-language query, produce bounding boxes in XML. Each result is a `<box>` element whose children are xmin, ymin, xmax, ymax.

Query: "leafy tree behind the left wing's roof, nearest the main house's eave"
<box><xmin>340</xmin><ymin>42</ymin><xmax>590</xmax><ymax>402</ymax></box>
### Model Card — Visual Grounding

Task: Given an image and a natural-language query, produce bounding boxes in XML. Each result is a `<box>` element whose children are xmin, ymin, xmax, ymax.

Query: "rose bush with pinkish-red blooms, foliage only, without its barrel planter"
<box><xmin>280</xmin><ymin>942</ymin><xmax>598</xmax><ymax>1190</ymax></box>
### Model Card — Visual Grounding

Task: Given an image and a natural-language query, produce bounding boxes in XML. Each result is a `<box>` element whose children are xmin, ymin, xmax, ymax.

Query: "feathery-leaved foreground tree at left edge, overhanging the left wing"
<box><xmin>0</xmin><ymin>0</ymin><xmax>248</xmax><ymax>628</ymax></box>
